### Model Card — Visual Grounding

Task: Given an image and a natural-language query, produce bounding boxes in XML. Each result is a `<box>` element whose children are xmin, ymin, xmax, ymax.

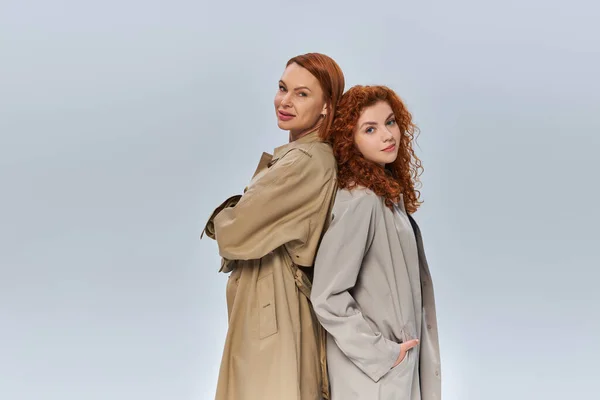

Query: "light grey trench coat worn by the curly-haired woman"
<box><xmin>311</xmin><ymin>188</ymin><xmax>441</xmax><ymax>400</ymax></box>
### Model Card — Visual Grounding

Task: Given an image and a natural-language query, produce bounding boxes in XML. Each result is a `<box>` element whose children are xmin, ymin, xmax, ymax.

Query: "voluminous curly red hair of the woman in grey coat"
<box><xmin>325</xmin><ymin>85</ymin><xmax>423</xmax><ymax>214</ymax></box>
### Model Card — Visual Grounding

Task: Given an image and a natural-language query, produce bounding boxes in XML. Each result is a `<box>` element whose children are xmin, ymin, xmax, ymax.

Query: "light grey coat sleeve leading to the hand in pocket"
<box><xmin>311</xmin><ymin>196</ymin><xmax>400</xmax><ymax>382</ymax></box>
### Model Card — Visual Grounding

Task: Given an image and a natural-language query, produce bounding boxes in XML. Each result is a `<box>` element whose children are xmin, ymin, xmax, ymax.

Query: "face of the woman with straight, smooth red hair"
<box><xmin>275</xmin><ymin>63</ymin><xmax>327</xmax><ymax>136</ymax></box>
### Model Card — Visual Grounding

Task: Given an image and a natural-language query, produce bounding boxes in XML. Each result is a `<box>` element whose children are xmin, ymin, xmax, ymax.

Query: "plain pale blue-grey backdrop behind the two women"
<box><xmin>0</xmin><ymin>0</ymin><xmax>600</xmax><ymax>400</ymax></box>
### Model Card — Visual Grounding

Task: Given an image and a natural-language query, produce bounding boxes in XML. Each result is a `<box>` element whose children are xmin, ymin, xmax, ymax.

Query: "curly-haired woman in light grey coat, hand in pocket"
<box><xmin>311</xmin><ymin>86</ymin><xmax>441</xmax><ymax>400</ymax></box>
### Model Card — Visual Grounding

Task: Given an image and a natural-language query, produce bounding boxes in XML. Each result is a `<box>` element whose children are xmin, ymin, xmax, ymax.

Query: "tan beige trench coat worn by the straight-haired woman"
<box><xmin>204</xmin><ymin>132</ymin><xmax>337</xmax><ymax>400</ymax></box>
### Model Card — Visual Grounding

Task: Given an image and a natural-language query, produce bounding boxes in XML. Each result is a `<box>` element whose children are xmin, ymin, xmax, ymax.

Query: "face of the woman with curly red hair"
<box><xmin>354</xmin><ymin>101</ymin><xmax>400</xmax><ymax>166</ymax></box>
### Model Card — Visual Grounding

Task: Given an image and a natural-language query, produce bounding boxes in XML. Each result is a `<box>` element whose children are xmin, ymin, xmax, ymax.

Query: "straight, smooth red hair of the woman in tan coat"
<box><xmin>286</xmin><ymin>53</ymin><xmax>345</xmax><ymax>139</ymax></box>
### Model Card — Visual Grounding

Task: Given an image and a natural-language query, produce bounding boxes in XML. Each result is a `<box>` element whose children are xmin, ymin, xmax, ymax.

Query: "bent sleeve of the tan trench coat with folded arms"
<box><xmin>214</xmin><ymin>149</ymin><xmax>335</xmax><ymax>260</ymax></box>
